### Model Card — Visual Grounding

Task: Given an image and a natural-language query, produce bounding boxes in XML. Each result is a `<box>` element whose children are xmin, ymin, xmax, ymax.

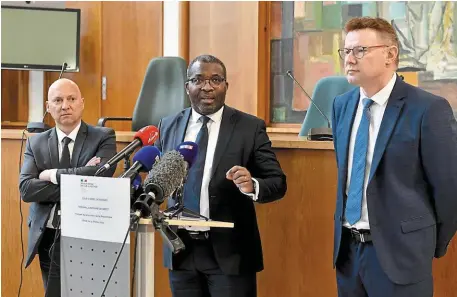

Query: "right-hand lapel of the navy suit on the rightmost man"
<box><xmin>368</xmin><ymin>77</ymin><xmax>406</xmax><ymax>181</ymax></box>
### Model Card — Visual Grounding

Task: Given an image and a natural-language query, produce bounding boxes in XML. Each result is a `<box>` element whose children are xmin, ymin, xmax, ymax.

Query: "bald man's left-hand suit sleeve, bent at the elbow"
<box><xmin>19</xmin><ymin>139</ymin><xmax>60</xmax><ymax>203</ymax></box>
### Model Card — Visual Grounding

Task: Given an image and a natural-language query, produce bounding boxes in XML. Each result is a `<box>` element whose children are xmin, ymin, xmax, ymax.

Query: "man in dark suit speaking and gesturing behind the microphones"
<box><xmin>156</xmin><ymin>55</ymin><xmax>286</xmax><ymax>297</ymax></box>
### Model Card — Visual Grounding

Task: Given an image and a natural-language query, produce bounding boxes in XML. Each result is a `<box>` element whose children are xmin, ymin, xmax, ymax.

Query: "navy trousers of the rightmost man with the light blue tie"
<box><xmin>336</xmin><ymin>227</ymin><xmax>433</xmax><ymax>297</ymax></box>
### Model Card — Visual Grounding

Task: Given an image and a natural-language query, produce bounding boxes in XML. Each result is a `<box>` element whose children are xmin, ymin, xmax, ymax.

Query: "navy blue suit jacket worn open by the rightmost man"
<box><xmin>332</xmin><ymin>77</ymin><xmax>457</xmax><ymax>284</ymax></box>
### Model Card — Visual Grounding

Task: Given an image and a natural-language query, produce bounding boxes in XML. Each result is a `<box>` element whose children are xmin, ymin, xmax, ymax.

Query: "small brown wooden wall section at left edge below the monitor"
<box><xmin>1</xmin><ymin>70</ymin><xmax>29</xmax><ymax>125</ymax></box>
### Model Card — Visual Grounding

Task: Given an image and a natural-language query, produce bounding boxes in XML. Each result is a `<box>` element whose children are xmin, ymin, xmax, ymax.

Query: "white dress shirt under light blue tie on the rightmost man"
<box><xmin>343</xmin><ymin>73</ymin><xmax>397</xmax><ymax>230</ymax></box>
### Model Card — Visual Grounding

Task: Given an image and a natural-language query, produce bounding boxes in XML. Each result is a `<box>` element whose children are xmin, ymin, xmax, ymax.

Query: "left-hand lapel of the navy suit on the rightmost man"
<box><xmin>340</xmin><ymin>88</ymin><xmax>360</xmax><ymax>185</ymax></box>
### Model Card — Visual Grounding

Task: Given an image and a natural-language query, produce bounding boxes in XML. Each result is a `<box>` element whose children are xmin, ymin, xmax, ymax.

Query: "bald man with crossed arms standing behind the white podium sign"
<box><xmin>19</xmin><ymin>79</ymin><xmax>116</xmax><ymax>297</ymax></box>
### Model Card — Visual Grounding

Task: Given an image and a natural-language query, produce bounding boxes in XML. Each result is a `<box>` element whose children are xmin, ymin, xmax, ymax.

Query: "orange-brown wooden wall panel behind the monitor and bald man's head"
<box><xmin>43</xmin><ymin>1</ymin><xmax>102</xmax><ymax>126</ymax></box>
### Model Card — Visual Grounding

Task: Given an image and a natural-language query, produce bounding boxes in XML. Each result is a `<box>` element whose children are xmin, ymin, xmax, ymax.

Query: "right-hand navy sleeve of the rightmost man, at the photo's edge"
<box><xmin>421</xmin><ymin>99</ymin><xmax>457</xmax><ymax>258</ymax></box>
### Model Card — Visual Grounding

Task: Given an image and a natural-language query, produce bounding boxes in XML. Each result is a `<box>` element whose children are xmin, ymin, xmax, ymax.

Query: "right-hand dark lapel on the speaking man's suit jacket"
<box><xmin>211</xmin><ymin>105</ymin><xmax>236</xmax><ymax>177</ymax></box>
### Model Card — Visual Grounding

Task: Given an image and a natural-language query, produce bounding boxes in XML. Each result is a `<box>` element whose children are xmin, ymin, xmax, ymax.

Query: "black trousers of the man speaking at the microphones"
<box><xmin>169</xmin><ymin>230</ymin><xmax>257</xmax><ymax>297</ymax></box>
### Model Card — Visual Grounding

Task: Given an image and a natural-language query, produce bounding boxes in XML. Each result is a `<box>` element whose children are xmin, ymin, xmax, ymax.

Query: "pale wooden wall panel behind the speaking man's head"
<box><xmin>189</xmin><ymin>1</ymin><xmax>259</xmax><ymax>115</ymax></box>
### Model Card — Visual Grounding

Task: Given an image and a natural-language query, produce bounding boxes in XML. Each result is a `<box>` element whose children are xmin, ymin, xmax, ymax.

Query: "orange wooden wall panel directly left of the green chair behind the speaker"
<box><xmin>101</xmin><ymin>2</ymin><xmax>163</xmax><ymax>131</ymax></box>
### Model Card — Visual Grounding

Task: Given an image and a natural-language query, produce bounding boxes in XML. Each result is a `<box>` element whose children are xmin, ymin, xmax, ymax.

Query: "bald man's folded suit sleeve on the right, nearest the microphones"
<box><xmin>56</xmin><ymin>129</ymin><xmax>116</xmax><ymax>184</ymax></box>
